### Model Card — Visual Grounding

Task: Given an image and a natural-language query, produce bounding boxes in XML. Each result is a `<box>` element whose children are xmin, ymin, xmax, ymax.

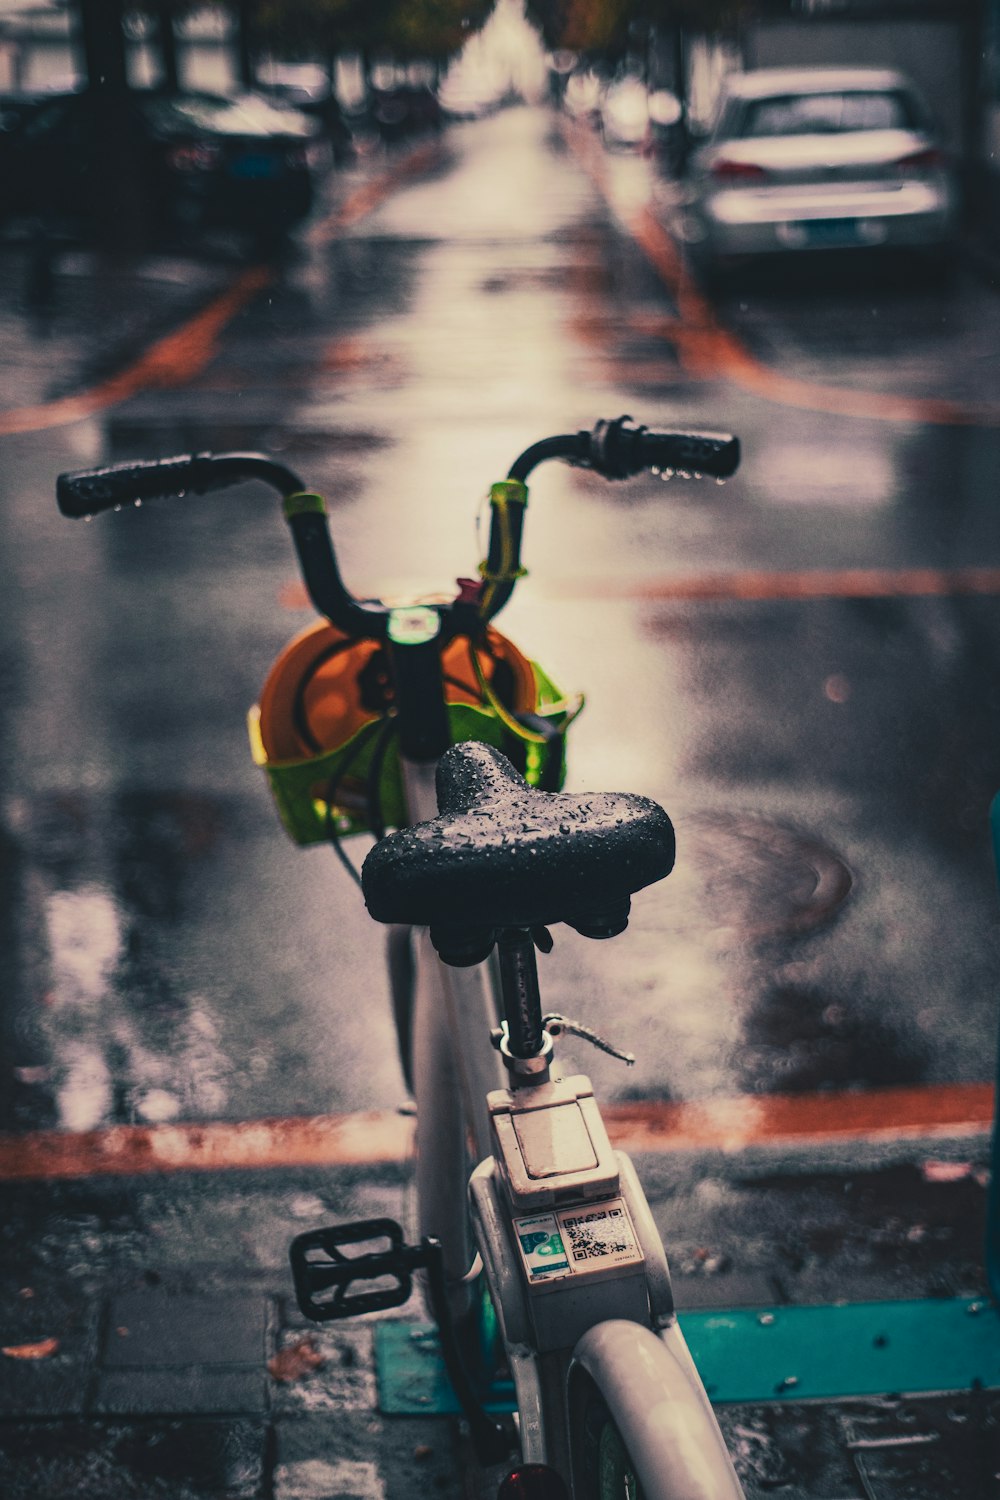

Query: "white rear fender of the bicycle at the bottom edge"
<box><xmin>568</xmin><ymin>1320</ymin><xmax>744</xmax><ymax>1500</ymax></box>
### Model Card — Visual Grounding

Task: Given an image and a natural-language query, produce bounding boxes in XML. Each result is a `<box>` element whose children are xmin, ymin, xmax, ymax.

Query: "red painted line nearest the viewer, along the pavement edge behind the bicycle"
<box><xmin>0</xmin><ymin>1083</ymin><xmax>993</xmax><ymax>1182</ymax></box>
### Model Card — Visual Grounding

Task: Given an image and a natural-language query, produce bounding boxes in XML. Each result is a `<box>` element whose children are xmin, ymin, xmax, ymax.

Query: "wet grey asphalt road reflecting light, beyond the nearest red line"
<box><xmin>0</xmin><ymin>110</ymin><xmax>1000</xmax><ymax>1496</ymax></box>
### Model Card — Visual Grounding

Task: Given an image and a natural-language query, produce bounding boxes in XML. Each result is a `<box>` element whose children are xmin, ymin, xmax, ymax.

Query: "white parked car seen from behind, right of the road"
<box><xmin>684</xmin><ymin>68</ymin><xmax>958</xmax><ymax>282</ymax></box>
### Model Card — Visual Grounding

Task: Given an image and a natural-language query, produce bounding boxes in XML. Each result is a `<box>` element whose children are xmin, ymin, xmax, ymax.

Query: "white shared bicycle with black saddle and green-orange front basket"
<box><xmin>57</xmin><ymin>417</ymin><xmax>742</xmax><ymax>1500</ymax></box>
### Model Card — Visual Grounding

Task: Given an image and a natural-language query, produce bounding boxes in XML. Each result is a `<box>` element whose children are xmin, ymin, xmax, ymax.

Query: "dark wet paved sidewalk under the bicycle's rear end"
<box><xmin>0</xmin><ymin>1142</ymin><xmax>1000</xmax><ymax>1500</ymax></box>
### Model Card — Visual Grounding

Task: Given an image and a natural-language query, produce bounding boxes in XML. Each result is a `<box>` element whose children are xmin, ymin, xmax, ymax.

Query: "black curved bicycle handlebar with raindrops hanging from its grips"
<box><xmin>55</xmin><ymin>417</ymin><xmax>739</xmax><ymax>639</ymax></box>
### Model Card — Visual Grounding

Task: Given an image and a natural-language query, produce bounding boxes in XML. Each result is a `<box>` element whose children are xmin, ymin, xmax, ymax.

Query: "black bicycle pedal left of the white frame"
<box><xmin>289</xmin><ymin>1218</ymin><xmax>427</xmax><ymax>1323</ymax></box>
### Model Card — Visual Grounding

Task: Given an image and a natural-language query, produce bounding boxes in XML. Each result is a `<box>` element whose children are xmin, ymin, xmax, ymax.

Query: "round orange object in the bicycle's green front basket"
<box><xmin>261</xmin><ymin>620</ymin><xmax>537</xmax><ymax>761</ymax></box>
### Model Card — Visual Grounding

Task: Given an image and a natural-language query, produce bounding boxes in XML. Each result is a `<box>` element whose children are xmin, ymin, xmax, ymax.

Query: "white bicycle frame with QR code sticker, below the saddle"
<box><xmin>403</xmin><ymin>762</ymin><xmax>742</xmax><ymax>1500</ymax></box>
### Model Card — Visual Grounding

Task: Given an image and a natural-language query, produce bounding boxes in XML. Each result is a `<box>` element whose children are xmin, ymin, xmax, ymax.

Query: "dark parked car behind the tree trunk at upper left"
<box><xmin>0</xmin><ymin>92</ymin><xmax>330</xmax><ymax>234</ymax></box>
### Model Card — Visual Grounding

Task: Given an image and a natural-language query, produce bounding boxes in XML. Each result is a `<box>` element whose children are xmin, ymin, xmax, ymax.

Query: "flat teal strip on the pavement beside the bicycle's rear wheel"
<box><xmin>375</xmin><ymin>1298</ymin><xmax>1000</xmax><ymax>1416</ymax></box>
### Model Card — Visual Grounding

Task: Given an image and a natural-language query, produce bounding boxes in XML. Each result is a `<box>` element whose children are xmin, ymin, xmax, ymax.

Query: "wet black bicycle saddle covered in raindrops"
<box><xmin>361</xmin><ymin>741</ymin><xmax>675</xmax><ymax>963</ymax></box>
